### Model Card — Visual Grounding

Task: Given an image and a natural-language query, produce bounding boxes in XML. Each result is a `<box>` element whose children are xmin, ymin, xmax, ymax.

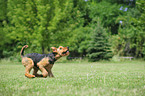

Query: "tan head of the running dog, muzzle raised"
<box><xmin>51</xmin><ymin>46</ymin><xmax>69</xmax><ymax>56</ymax></box>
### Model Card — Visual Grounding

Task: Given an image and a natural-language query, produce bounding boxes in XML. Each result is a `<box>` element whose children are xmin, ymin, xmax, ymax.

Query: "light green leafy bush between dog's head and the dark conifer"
<box><xmin>69</xmin><ymin>27</ymin><xmax>91</xmax><ymax>56</ymax></box>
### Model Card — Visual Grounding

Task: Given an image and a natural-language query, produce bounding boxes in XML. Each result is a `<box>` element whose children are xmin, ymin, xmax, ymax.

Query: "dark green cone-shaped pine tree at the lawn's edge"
<box><xmin>88</xmin><ymin>22</ymin><xmax>112</xmax><ymax>62</ymax></box>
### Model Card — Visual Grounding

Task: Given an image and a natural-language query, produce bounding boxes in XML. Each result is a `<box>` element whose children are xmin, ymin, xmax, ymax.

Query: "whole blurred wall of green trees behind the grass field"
<box><xmin>0</xmin><ymin>0</ymin><xmax>145</xmax><ymax>61</ymax></box>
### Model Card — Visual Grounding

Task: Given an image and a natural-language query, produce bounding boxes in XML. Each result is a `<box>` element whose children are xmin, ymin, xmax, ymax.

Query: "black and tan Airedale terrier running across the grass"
<box><xmin>20</xmin><ymin>45</ymin><xmax>69</xmax><ymax>78</ymax></box>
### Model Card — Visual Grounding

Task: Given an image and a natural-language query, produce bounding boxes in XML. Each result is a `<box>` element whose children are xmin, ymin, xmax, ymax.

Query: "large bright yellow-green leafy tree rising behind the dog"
<box><xmin>4</xmin><ymin>0</ymin><xmax>78</xmax><ymax>53</ymax></box>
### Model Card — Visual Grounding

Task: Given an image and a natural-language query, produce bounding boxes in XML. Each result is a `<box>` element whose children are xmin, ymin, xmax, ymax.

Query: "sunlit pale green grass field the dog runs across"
<box><xmin>0</xmin><ymin>61</ymin><xmax>145</xmax><ymax>96</ymax></box>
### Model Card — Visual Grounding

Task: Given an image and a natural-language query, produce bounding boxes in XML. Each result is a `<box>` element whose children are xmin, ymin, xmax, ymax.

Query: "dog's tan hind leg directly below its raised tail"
<box><xmin>22</xmin><ymin>57</ymin><xmax>35</xmax><ymax>78</ymax></box>
